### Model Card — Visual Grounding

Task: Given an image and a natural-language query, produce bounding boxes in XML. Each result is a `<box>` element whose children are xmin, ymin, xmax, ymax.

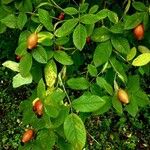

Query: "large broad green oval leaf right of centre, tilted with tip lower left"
<box><xmin>93</xmin><ymin>41</ymin><xmax>112</xmax><ymax>67</ymax></box>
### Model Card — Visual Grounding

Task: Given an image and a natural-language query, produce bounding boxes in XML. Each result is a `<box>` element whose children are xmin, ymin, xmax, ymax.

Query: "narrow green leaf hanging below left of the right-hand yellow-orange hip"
<box><xmin>112</xmin><ymin>94</ymin><xmax>123</xmax><ymax>114</ymax></box>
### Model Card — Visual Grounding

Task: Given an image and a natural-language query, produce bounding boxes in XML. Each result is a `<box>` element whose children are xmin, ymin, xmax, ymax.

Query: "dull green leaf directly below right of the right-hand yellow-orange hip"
<box><xmin>126</xmin><ymin>96</ymin><xmax>138</xmax><ymax>117</ymax></box>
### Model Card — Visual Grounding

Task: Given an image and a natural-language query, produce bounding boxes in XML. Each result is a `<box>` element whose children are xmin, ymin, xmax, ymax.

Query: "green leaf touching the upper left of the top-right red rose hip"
<box><xmin>124</xmin><ymin>13</ymin><xmax>143</xmax><ymax>30</ymax></box>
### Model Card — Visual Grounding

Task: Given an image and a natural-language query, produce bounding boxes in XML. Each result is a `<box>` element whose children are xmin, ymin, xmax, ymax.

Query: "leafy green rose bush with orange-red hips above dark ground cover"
<box><xmin>0</xmin><ymin>0</ymin><xmax>150</xmax><ymax>150</ymax></box>
